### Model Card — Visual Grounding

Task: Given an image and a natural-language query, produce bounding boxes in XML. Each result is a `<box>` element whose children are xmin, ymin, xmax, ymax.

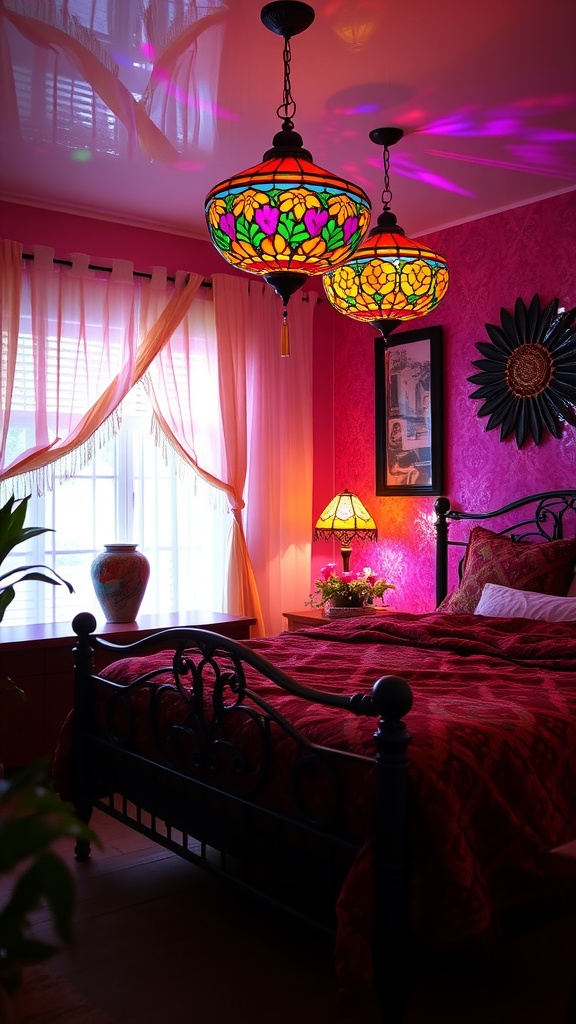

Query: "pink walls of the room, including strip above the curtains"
<box><xmin>0</xmin><ymin>191</ymin><xmax>576</xmax><ymax>611</ymax></box>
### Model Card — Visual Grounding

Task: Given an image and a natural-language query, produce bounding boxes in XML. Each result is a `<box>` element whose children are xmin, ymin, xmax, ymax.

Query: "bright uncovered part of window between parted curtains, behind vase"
<box><xmin>3</xmin><ymin>389</ymin><xmax>231</xmax><ymax>625</ymax></box>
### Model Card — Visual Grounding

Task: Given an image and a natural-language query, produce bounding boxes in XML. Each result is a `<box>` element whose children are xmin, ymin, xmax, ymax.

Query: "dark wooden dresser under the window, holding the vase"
<box><xmin>0</xmin><ymin>610</ymin><xmax>256</xmax><ymax>771</ymax></box>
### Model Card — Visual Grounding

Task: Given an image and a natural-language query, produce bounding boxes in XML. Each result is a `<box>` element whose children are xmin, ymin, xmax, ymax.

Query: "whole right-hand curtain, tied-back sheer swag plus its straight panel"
<box><xmin>142</xmin><ymin>274</ymin><xmax>316</xmax><ymax>633</ymax></box>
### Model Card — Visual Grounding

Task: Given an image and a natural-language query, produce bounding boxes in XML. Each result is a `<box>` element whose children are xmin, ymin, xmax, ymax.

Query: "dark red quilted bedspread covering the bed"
<box><xmin>52</xmin><ymin>612</ymin><xmax>576</xmax><ymax>987</ymax></box>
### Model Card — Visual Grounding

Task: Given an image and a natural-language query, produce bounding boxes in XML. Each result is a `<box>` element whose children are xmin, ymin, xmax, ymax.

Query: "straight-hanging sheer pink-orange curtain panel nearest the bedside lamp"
<box><xmin>239</xmin><ymin>282</ymin><xmax>317</xmax><ymax>633</ymax></box>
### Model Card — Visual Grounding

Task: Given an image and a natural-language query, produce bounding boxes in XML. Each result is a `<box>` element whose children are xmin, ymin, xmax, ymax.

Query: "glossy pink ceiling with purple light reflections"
<box><xmin>0</xmin><ymin>0</ymin><xmax>576</xmax><ymax>243</ymax></box>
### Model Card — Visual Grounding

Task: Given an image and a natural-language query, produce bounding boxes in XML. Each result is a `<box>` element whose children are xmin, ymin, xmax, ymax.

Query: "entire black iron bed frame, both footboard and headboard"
<box><xmin>65</xmin><ymin>489</ymin><xmax>576</xmax><ymax>1024</ymax></box>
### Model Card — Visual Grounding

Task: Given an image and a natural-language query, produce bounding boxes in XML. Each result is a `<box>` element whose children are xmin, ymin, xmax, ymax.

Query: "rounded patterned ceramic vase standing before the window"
<box><xmin>90</xmin><ymin>544</ymin><xmax>150</xmax><ymax>623</ymax></box>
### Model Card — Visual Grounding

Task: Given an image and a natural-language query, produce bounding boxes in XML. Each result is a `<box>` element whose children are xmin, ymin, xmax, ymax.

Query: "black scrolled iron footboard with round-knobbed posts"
<box><xmin>71</xmin><ymin>613</ymin><xmax>412</xmax><ymax>977</ymax></box>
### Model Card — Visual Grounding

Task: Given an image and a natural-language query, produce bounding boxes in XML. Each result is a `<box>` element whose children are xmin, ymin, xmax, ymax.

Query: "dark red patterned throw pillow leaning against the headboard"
<box><xmin>438</xmin><ymin>526</ymin><xmax>576</xmax><ymax>612</ymax></box>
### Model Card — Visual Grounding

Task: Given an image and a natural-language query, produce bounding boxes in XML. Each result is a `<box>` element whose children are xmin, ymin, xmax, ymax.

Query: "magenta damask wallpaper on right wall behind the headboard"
<box><xmin>327</xmin><ymin>191</ymin><xmax>576</xmax><ymax>612</ymax></box>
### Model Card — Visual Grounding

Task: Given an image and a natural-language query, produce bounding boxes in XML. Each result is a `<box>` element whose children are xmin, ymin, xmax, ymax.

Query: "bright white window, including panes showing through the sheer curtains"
<box><xmin>1</xmin><ymin>272</ymin><xmax>232</xmax><ymax>625</ymax></box>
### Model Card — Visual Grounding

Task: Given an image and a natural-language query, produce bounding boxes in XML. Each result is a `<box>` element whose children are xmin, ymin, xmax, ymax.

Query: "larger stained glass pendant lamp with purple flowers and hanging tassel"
<box><xmin>205</xmin><ymin>0</ymin><xmax>370</xmax><ymax>354</ymax></box>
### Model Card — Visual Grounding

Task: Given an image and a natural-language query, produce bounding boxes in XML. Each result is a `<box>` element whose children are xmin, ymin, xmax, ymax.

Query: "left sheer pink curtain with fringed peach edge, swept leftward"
<box><xmin>0</xmin><ymin>247</ymin><xmax>202</xmax><ymax>490</ymax></box>
